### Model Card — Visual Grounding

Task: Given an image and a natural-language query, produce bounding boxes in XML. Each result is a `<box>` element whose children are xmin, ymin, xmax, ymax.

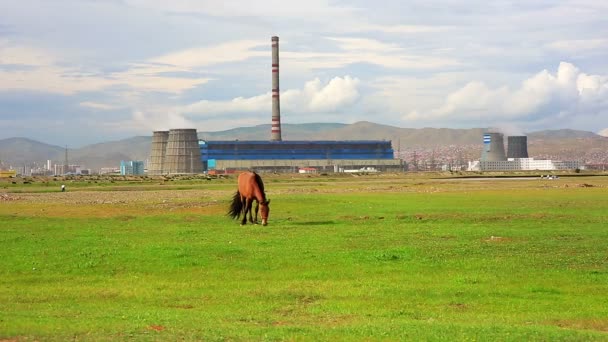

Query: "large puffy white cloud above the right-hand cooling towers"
<box><xmin>403</xmin><ymin>62</ymin><xmax>608</xmax><ymax>123</ymax></box>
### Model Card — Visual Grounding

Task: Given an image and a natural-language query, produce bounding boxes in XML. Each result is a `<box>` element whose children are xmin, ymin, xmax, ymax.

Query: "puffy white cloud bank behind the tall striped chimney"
<box><xmin>179</xmin><ymin>76</ymin><xmax>360</xmax><ymax>116</ymax></box>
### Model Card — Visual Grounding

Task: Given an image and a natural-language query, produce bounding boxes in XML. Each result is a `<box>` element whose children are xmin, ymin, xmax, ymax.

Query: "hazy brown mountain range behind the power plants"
<box><xmin>0</xmin><ymin>121</ymin><xmax>608</xmax><ymax>170</ymax></box>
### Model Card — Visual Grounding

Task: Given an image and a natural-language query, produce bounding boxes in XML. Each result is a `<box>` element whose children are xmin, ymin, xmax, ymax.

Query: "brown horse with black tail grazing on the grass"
<box><xmin>228</xmin><ymin>172</ymin><xmax>270</xmax><ymax>226</ymax></box>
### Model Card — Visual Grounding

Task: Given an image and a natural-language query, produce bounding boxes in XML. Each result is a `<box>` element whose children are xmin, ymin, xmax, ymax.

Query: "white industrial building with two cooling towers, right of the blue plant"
<box><xmin>468</xmin><ymin>132</ymin><xmax>583</xmax><ymax>171</ymax></box>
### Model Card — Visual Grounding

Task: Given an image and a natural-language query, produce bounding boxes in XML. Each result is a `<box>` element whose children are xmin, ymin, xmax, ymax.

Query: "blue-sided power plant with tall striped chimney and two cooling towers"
<box><xmin>148</xmin><ymin>36</ymin><xmax>403</xmax><ymax>175</ymax></box>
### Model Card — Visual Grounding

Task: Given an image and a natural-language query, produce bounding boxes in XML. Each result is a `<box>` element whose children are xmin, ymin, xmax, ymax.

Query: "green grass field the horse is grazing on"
<box><xmin>0</xmin><ymin>175</ymin><xmax>608</xmax><ymax>341</ymax></box>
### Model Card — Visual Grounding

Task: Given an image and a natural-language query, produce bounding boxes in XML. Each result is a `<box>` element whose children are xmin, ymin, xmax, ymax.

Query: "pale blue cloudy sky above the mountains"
<box><xmin>0</xmin><ymin>0</ymin><xmax>608</xmax><ymax>147</ymax></box>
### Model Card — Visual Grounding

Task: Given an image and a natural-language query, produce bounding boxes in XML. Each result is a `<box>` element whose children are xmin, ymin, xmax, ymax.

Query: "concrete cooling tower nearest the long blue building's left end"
<box><xmin>163</xmin><ymin>128</ymin><xmax>203</xmax><ymax>174</ymax></box>
